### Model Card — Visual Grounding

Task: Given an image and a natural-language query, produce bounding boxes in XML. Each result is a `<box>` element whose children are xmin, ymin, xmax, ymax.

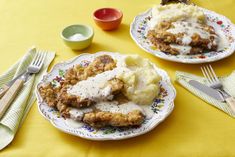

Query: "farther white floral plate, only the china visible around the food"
<box><xmin>130</xmin><ymin>8</ymin><xmax>235</xmax><ymax>64</ymax></box>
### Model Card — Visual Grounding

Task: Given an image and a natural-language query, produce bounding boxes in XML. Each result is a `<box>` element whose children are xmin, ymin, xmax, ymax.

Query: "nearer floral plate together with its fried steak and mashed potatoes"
<box><xmin>36</xmin><ymin>52</ymin><xmax>176</xmax><ymax>140</ymax></box>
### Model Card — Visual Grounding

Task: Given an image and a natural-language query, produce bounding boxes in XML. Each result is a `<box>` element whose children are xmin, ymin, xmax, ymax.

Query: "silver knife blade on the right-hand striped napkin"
<box><xmin>189</xmin><ymin>80</ymin><xmax>225</xmax><ymax>101</ymax></box>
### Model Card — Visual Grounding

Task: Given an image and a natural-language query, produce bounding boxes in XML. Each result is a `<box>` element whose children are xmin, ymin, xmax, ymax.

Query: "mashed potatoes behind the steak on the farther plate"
<box><xmin>149</xmin><ymin>3</ymin><xmax>205</xmax><ymax>29</ymax></box>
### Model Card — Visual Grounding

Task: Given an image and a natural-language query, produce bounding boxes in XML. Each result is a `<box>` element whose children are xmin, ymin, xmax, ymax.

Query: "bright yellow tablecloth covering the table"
<box><xmin>0</xmin><ymin>0</ymin><xmax>235</xmax><ymax>157</ymax></box>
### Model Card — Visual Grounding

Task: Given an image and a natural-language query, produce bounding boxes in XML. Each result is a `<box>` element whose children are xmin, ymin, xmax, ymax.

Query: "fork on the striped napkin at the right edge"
<box><xmin>201</xmin><ymin>65</ymin><xmax>235</xmax><ymax>113</ymax></box>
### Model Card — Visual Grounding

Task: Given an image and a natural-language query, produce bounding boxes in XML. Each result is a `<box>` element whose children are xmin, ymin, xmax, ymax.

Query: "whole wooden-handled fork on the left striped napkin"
<box><xmin>0</xmin><ymin>51</ymin><xmax>46</xmax><ymax>119</ymax></box>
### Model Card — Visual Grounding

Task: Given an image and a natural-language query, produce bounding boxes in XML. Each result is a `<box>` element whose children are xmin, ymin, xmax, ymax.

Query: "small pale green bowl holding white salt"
<box><xmin>61</xmin><ymin>24</ymin><xmax>94</xmax><ymax>50</ymax></box>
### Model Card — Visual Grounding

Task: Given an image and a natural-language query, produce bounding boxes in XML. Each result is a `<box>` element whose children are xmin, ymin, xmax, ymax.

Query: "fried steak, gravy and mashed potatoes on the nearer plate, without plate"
<box><xmin>39</xmin><ymin>55</ymin><xmax>161</xmax><ymax>127</ymax></box>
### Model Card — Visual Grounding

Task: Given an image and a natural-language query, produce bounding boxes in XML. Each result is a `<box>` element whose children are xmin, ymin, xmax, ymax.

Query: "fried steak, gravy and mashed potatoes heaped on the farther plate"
<box><xmin>147</xmin><ymin>3</ymin><xmax>224</xmax><ymax>55</ymax></box>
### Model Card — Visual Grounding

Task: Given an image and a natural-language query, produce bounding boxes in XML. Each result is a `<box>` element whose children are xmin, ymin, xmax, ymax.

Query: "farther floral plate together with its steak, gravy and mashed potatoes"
<box><xmin>130</xmin><ymin>4</ymin><xmax>235</xmax><ymax>64</ymax></box>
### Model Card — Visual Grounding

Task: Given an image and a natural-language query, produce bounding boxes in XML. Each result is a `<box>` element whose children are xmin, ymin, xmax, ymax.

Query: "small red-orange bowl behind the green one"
<box><xmin>93</xmin><ymin>8</ymin><xmax>123</xmax><ymax>30</ymax></box>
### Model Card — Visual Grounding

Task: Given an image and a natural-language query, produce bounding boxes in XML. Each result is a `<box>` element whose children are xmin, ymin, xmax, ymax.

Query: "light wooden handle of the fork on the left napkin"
<box><xmin>0</xmin><ymin>79</ymin><xmax>24</xmax><ymax>119</ymax></box>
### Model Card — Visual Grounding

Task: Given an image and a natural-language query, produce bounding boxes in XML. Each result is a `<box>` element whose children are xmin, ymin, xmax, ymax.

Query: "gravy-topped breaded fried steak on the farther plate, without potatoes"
<box><xmin>147</xmin><ymin>21</ymin><xmax>218</xmax><ymax>55</ymax></box>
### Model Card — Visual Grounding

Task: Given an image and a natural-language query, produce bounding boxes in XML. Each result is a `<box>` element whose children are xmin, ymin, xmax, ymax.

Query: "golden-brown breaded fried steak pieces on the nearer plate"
<box><xmin>39</xmin><ymin>55</ymin><xmax>145</xmax><ymax>127</ymax></box>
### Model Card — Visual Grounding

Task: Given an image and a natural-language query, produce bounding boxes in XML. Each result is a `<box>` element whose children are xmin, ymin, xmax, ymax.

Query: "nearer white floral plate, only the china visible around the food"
<box><xmin>36</xmin><ymin>52</ymin><xmax>176</xmax><ymax>140</ymax></box>
